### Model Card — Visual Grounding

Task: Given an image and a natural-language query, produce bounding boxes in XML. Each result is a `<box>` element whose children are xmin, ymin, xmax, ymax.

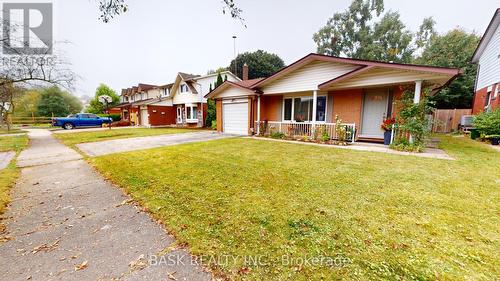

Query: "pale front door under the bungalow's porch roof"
<box><xmin>360</xmin><ymin>90</ymin><xmax>389</xmax><ymax>138</ymax></box>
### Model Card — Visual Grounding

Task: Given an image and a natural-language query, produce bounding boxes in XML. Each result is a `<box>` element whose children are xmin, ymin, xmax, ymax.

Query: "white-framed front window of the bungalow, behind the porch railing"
<box><xmin>283</xmin><ymin>96</ymin><xmax>326</xmax><ymax>122</ymax></box>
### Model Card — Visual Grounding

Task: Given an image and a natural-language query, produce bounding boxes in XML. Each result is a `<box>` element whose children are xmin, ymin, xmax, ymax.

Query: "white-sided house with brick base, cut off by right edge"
<box><xmin>472</xmin><ymin>9</ymin><xmax>500</xmax><ymax>114</ymax></box>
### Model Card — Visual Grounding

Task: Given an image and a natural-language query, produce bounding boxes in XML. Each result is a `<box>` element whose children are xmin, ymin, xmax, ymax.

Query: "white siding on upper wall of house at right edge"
<box><xmin>476</xmin><ymin>25</ymin><xmax>500</xmax><ymax>90</ymax></box>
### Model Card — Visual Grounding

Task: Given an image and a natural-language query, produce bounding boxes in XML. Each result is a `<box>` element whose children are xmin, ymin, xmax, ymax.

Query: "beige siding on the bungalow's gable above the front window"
<box><xmin>262</xmin><ymin>61</ymin><xmax>359</xmax><ymax>94</ymax></box>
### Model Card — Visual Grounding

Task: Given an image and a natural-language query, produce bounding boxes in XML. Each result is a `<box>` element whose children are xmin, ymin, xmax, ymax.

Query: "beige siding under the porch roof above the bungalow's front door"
<box><xmin>331</xmin><ymin>68</ymin><xmax>451</xmax><ymax>89</ymax></box>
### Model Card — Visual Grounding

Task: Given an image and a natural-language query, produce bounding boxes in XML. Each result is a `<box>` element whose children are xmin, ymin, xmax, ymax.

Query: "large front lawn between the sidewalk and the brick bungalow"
<box><xmin>89</xmin><ymin>136</ymin><xmax>500</xmax><ymax>280</ymax></box>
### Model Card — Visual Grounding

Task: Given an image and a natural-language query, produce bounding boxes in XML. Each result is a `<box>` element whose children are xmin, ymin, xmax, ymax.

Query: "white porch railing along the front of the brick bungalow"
<box><xmin>255</xmin><ymin>121</ymin><xmax>356</xmax><ymax>142</ymax></box>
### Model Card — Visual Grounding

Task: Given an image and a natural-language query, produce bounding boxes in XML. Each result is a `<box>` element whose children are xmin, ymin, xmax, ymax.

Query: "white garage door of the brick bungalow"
<box><xmin>222</xmin><ymin>102</ymin><xmax>248</xmax><ymax>135</ymax></box>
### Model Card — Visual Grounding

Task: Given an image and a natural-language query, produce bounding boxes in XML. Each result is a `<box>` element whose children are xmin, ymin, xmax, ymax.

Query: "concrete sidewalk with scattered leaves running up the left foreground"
<box><xmin>0</xmin><ymin>130</ymin><xmax>211</xmax><ymax>280</ymax></box>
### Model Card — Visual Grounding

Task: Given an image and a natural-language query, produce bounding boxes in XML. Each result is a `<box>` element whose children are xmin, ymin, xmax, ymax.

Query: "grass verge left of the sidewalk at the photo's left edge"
<box><xmin>0</xmin><ymin>135</ymin><xmax>28</xmax><ymax>233</ymax></box>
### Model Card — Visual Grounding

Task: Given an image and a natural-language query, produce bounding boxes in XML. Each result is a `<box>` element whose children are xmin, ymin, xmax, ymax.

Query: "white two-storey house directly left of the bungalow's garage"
<box><xmin>171</xmin><ymin>71</ymin><xmax>241</xmax><ymax>127</ymax></box>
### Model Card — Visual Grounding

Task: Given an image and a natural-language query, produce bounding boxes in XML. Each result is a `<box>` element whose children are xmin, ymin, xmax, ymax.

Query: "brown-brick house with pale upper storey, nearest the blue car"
<box><xmin>115</xmin><ymin>83</ymin><xmax>176</xmax><ymax>127</ymax></box>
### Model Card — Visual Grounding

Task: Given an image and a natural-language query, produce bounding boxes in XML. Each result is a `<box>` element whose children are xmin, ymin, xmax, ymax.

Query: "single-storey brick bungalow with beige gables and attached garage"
<box><xmin>206</xmin><ymin>54</ymin><xmax>460</xmax><ymax>141</ymax></box>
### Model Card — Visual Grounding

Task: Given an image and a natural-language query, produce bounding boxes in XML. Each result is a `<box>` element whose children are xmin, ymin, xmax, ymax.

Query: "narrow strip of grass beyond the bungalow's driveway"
<box><xmin>53</xmin><ymin>128</ymin><xmax>197</xmax><ymax>147</ymax></box>
